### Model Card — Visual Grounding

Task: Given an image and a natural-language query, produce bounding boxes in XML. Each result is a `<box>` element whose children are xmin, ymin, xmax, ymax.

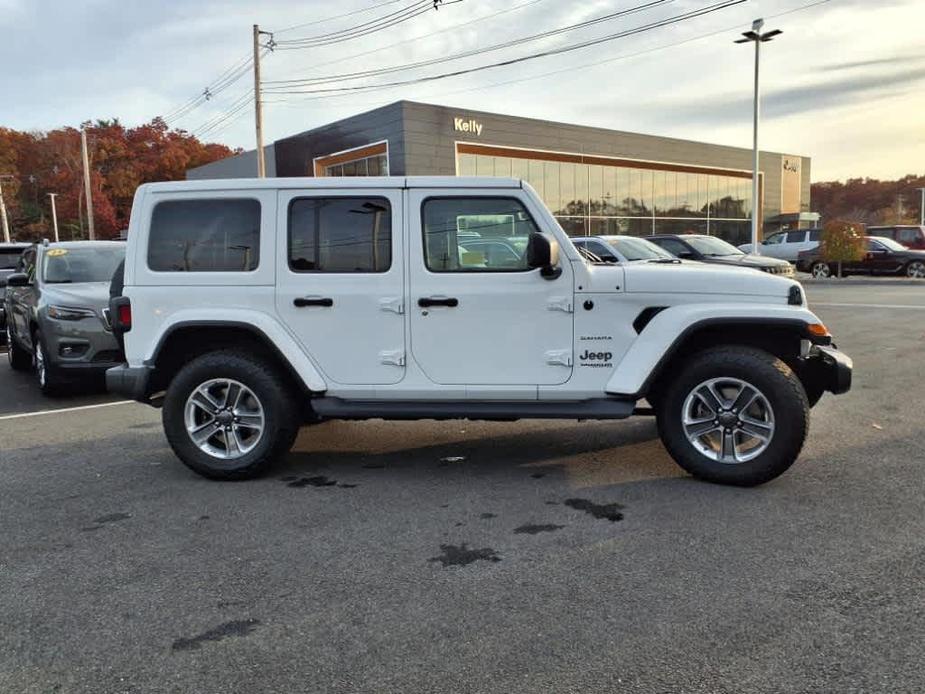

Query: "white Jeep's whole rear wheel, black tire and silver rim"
<box><xmin>162</xmin><ymin>351</ymin><xmax>299</xmax><ymax>480</ymax></box>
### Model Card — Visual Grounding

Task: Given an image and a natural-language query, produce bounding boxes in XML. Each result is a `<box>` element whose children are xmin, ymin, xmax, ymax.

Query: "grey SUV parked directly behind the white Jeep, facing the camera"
<box><xmin>4</xmin><ymin>241</ymin><xmax>125</xmax><ymax>393</ymax></box>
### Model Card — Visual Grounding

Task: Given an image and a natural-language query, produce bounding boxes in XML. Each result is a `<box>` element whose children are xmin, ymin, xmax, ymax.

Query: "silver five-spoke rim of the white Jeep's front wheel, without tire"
<box><xmin>681</xmin><ymin>377</ymin><xmax>774</xmax><ymax>464</ymax></box>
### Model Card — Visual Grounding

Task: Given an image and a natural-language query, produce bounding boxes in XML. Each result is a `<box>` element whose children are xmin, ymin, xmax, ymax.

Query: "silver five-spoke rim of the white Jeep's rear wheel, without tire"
<box><xmin>183</xmin><ymin>378</ymin><xmax>266</xmax><ymax>460</ymax></box>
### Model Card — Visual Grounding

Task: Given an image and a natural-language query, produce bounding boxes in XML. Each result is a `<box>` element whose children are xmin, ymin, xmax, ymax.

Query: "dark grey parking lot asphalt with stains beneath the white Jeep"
<box><xmin>0</xmin><ymin>285</ymin><xmax>925</xmax><ymax>694</ymax></box>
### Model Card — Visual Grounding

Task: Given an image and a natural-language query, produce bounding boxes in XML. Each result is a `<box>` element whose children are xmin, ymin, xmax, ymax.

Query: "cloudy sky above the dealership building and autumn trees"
<box><xmin>0</xmin><ymin>0</ymin><xmax>925</xmax><ymax>180</ymax></box>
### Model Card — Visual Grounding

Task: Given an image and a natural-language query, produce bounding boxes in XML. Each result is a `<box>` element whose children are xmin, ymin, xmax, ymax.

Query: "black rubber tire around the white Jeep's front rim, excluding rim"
<box><xmin>657</xmin><ymin>346</ymin><xmax>809</xmax><ymax>487</ymax></box>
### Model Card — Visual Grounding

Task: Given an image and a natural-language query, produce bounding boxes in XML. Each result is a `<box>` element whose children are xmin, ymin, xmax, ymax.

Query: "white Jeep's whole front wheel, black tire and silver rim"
<box><xmin>658</xmin><ymin>347</ymin><xmax>809</xmax><ymax>486</ymax></box>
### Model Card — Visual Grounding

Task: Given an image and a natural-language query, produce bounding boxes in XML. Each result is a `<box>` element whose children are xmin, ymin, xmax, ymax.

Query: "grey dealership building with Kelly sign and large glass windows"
<box><xmin>187</xmin><ymin>101</ymin><xmax>818</xmax><ymax>244</ymax></box>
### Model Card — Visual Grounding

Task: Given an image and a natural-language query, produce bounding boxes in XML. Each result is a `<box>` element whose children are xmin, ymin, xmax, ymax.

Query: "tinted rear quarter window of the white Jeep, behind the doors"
<box><xmin>148</xmin><ymin>198</ymin><xmax>260</xmax><ymax>272</ymax></box>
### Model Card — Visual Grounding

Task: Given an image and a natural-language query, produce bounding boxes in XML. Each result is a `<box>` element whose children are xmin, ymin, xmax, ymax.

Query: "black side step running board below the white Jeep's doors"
<box><xmin>311</xmin><ymin>397</ymin><xmax>636</xmax><ymax>420</ymax></box>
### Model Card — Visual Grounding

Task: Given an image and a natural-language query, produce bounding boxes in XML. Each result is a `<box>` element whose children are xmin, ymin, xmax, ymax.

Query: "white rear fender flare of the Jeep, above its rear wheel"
<box><xmin>144</xmin><ymin>309</ymin><xmax>328</xmax><ymax>393</ymax></box>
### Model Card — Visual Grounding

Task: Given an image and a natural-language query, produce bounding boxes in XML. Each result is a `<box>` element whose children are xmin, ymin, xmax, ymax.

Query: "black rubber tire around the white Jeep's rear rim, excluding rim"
<box><xmin>162</xmin><ymin>350</ymin><xmax>300</xmax><ymax>480</ymax></box>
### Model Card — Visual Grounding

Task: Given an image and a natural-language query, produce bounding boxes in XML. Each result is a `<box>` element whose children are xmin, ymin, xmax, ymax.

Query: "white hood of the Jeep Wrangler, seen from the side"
<box><xmin>624</xmin><ymin>261</ymin><xmax>799</xmax><ymax>301</ymax></box>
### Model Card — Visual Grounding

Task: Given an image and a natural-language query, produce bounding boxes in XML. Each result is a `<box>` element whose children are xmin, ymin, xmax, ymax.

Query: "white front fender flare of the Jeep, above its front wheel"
<box><xmin>604</xmin><ymin>304</ymin><xmax>822</xmax><ymax>398</ymax></box>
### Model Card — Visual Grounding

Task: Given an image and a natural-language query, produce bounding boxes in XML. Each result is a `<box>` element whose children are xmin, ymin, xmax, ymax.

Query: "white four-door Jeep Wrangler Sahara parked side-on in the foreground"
<box><xmin>107</xmin><ymin>177</ymin><xmax>852</xmax><ymax>485</ymax></box>
